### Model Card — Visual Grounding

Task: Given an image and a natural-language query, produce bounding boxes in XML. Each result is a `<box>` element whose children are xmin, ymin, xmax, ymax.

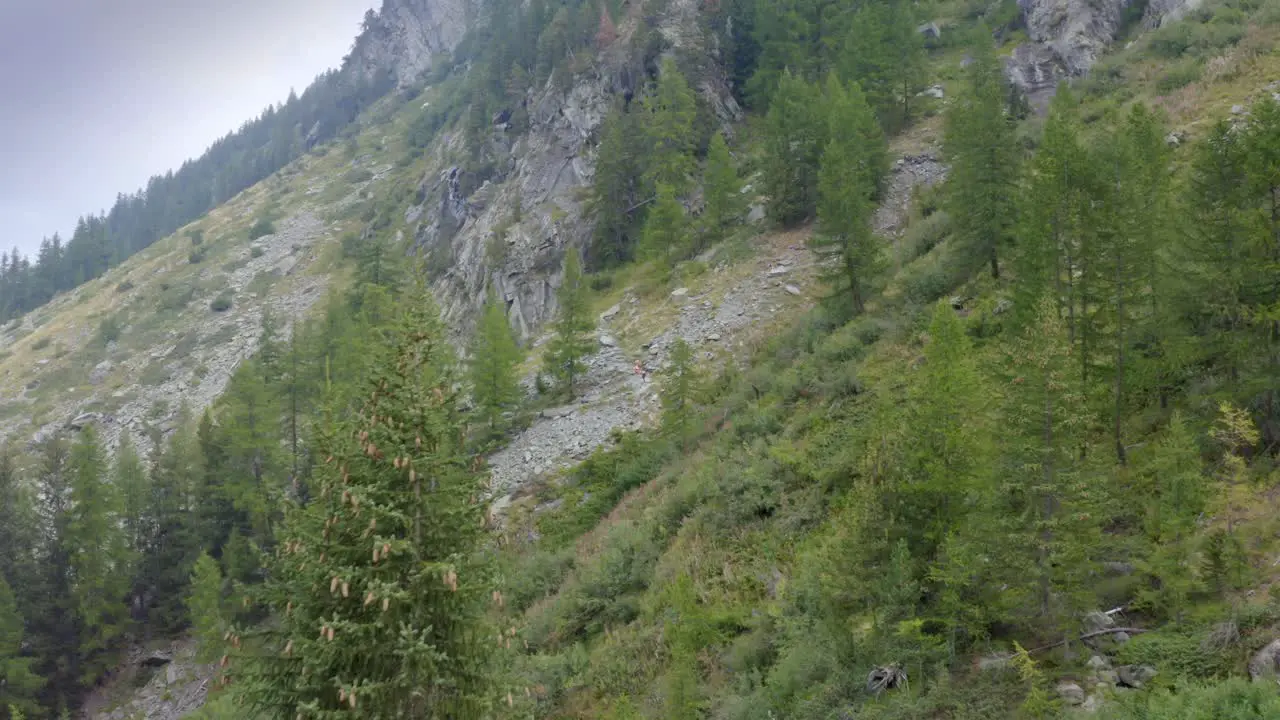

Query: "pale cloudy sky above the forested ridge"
<box><xmin>0</xmin><ymin>0</ymin><xmax>380</xmax><ymax>252</ymax></box>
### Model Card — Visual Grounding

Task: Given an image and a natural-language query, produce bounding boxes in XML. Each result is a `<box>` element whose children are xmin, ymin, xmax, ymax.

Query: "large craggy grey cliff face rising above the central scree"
<box><xmin>406</xmin><ymin>0</ymin><xmax>740</xmax><ymax>338</ymax></box>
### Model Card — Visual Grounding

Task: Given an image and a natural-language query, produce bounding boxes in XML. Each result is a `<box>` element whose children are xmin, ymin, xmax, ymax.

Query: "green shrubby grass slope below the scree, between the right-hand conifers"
<box><xmin>486</xmin><ymin>5</ymin><xmax>1280</xmax><ymax>719</ymax></box>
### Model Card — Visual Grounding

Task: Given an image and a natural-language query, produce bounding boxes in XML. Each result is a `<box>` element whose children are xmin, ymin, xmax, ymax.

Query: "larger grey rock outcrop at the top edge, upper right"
<box><xmin>1018</xmin><ymin>0</ymin><xmax>1129</xmax><ymax>76</ymax></box>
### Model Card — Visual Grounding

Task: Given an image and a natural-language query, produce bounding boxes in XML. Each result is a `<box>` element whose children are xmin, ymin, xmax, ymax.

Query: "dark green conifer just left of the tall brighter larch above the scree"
<box><xmin>760</xmin><ymin>72</ymin><xmax>827</xmax><ymax>225</ymax></box>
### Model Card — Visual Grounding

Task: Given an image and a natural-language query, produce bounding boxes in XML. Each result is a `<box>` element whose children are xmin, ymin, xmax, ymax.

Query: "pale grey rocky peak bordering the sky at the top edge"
<box><xmin>346</xmin><ymin>0</ymin><xmax>475</xmax><ymax>87</ymax></box>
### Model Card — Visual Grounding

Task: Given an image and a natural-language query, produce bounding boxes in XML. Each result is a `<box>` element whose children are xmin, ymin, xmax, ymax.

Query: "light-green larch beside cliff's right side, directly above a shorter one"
<box><xmin>641</xmin><ymin>58</ymin><xmax>698</xmax><ymax>195</ymax></box>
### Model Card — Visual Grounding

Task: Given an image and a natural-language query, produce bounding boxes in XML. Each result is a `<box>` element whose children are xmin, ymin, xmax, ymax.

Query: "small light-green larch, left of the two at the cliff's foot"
<box><xmin>468</xmin><ymin>290</ymin><xmax>520</xmax><ymax>434</ymax></box>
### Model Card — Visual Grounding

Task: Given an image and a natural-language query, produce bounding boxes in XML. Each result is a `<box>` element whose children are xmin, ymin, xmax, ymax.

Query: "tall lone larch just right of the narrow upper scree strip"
<box><xmin>945</xmin><ymin>31</ymin><xmax>1018</xmax><ymax>278</ymax></box>
